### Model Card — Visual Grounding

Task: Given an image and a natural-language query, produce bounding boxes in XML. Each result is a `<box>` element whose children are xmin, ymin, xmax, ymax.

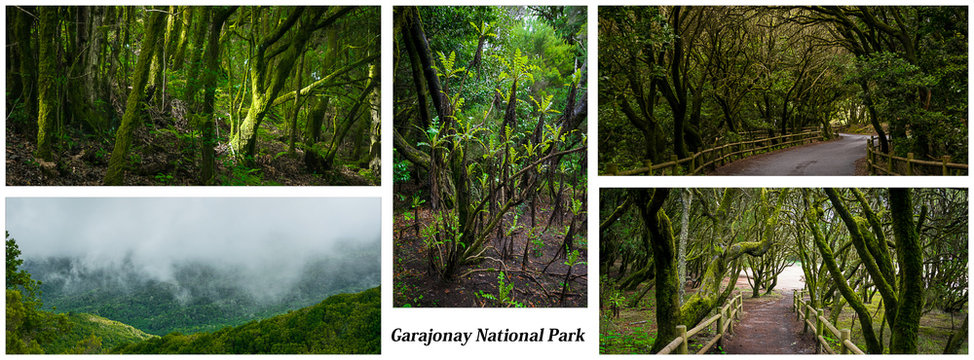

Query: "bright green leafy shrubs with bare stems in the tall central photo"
<box><xmin>395</xmin><ymin>7</ymin><xmax>585</xmax><ymax>282</ymax></box>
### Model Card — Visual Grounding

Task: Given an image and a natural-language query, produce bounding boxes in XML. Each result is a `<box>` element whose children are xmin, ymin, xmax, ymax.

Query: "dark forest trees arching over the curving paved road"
<box><xmin>598</xmin><ymin>6</ymin><xmax>968</xmax><ymax>172</ymax></box>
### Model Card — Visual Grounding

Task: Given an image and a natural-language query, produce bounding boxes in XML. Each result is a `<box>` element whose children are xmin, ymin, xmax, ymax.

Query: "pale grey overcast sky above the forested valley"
<box><xmin>6</xmin><ymin>198</ymin><xmax>381</xmax><ymax>277</ymax></box>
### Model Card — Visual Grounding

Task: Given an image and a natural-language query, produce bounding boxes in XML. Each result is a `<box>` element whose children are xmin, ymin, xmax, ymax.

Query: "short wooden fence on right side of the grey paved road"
<box><xmin>866</xmin><ymin>136</ymin><xmax>967</xmax><ymax>175</ymax></box>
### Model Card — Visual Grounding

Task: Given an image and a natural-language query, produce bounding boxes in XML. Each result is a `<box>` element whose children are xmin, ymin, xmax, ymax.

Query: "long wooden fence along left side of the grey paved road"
<box><xmin>605</xmin><ymin>129</ymin><xmax>822</xmax><ymax>176</ymax></box>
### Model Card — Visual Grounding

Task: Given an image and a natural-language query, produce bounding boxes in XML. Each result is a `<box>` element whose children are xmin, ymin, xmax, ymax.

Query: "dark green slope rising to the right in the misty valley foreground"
<box><xmin>113</xmin><ymin>287</ymin><xmax>381</xmax><ymax>354</ymax></box>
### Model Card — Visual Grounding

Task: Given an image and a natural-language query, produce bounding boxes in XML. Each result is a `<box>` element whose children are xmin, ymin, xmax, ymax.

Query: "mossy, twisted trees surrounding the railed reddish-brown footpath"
<box><xmin>599</xmin><ymin>188</ymin><xmax>969</xmax><ymax>354</ymax></box>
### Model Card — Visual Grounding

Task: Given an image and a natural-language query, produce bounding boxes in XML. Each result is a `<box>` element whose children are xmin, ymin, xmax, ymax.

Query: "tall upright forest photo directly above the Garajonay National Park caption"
<box><xmin>393</xmin><ymin>6</ymin><xmax>588</xmax><ymax>307</ymax></box>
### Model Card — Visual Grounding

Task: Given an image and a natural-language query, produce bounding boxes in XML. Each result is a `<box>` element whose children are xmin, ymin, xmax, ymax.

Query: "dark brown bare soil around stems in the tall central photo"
<box><xmin>393</xmin><ymin>188</ymin><xmax>588</xmax><ymax>307</ymax></box>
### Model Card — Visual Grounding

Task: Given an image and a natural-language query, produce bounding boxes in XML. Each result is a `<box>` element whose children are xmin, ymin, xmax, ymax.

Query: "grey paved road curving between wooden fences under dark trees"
<box><xmin>714</xmin><ymin>134</ymin><xmax>869</xmax><ymax>176</ymax></box>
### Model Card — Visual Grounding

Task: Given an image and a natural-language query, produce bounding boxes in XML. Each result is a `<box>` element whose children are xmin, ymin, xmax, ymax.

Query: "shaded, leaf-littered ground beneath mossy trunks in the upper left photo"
<box><xmin>6</xmin><ymin>114</ymin><xmax>378</xmax><ymax>186</ymax></box>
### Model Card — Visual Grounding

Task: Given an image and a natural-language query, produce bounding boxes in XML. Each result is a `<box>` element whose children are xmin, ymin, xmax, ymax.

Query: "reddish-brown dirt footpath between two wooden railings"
<box><xmin>724</xmin><ymin>291</ymin><xmax>815</xmax><ymax>354</ymax></box>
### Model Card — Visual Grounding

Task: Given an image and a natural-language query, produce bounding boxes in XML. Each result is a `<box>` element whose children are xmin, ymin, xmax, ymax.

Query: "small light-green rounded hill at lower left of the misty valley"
<box><xmin>44</xmin><ymin>313</ymin><xmax>157</xmax><ymax>354</ymax></box>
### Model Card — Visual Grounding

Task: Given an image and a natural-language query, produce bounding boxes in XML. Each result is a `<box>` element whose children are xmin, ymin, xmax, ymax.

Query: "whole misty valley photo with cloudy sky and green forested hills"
<box><xmin>6</xmin><ymin>198</ymin><xmax>381</xmax><ymax>354</ymax></box>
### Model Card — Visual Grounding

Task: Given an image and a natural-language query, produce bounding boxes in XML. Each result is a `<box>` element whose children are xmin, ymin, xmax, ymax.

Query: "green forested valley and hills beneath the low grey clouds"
<box><xmin>7</xmin><ymin>234</ymin><xmax>381</xmax><ymax>354</ymax></box>
